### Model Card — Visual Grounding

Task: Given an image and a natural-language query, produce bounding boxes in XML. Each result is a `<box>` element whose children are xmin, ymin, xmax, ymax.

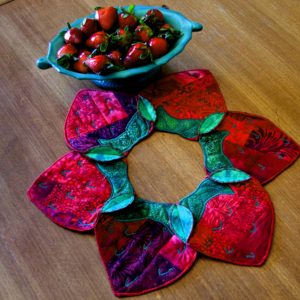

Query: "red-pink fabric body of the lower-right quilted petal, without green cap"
<box><xmin>189</xmin><ymin>179</ymin><xmax>274</xmax><ymax>266</ymax></box>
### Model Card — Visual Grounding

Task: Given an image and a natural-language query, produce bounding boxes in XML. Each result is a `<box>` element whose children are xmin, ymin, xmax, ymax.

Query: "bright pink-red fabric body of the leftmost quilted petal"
<box><xmin>28</xmin><ymin>152</ymin><xmax>111</xmax><ymax>231</ymax></box>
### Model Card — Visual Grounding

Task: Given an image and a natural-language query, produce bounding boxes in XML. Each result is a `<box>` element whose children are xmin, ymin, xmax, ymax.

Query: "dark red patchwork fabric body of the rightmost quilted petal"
<box><xmin>218</xmin><ymin>112</ymin><xmax>300</xmax><ymax>184</ymax></box>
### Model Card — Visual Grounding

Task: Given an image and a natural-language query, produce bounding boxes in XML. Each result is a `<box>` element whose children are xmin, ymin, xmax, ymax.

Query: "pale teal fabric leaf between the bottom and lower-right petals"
<box><xmin>170</xmin><ymin>205</ymin><xmax>194</xmax><ymax>243</ymax></box>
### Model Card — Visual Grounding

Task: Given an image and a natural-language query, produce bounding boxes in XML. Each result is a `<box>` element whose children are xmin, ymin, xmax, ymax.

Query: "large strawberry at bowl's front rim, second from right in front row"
<box><xmin>124</xmin><ymin>43</ymin><xmax>152</xmax><ymax>68</ymax></box>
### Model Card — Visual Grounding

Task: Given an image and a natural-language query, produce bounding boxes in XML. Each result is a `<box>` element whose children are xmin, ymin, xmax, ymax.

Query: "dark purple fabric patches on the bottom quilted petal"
<box><xmin>107</xmin><ymin>221</ymin><xmax>180</xmax><ymax>292</ymax></box>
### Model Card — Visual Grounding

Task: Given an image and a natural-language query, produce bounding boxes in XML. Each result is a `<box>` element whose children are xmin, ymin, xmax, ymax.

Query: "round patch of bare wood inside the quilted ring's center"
<box><xmin>128</xmin><ymin>132</ymin><xmax>205</xmax><ymax>203</ymax></box>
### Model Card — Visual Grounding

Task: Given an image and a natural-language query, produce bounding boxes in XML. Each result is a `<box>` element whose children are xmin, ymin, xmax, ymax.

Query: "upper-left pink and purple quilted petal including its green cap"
<box><xmin>65</xmin><ymin>89</ymin><xmax>153</xmax><ymax>161</ymax></box>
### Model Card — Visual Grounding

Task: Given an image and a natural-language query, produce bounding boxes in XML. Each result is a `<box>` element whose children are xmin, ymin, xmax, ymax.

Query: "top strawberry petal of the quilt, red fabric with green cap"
<box><xmin>141</xmin><ymin>69</ymin><xmax>227</xmax><ymax>139</ymax></box>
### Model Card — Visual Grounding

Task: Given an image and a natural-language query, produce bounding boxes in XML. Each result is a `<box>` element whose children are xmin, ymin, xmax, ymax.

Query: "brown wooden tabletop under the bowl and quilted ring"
<box><xmin>0</xmin><ymin>0</ymin><xmax>300</xmax><ymax>300</ymax></box>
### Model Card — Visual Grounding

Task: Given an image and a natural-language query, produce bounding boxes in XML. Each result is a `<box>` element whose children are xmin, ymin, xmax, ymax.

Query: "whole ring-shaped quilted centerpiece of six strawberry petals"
<box><xmin>28</xmin><ymin>70</ymin><xmax>299</xmax><ymax>296</ymax></box>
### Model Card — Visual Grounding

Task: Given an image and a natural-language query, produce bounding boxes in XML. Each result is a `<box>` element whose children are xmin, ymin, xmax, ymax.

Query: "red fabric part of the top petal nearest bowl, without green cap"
<box><xmin>140</xmin><ymin>69</ymin><xmax>227</xmax><ymax>119</ymax></box>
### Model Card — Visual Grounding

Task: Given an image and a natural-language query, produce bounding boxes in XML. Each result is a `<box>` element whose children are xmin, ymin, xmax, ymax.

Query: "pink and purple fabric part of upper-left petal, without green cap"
<box><xmin>65</xmin><ymin>89</ymin><xmax>138</xmax><ymax>152</ymax></box>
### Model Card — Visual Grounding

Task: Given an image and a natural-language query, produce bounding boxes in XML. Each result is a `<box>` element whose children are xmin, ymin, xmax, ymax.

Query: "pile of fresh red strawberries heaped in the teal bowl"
<box><xmin>57</xmin><ymin>5</ymin><xmax>181</xmax><ymax>75</ymax></box>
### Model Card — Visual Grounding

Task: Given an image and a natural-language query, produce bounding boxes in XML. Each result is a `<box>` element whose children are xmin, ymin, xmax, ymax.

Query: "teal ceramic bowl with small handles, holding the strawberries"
<box><xmin>36</xmin><ymin>5</ymin><xmax>203</xmax><ymax>89</ymax></box>
